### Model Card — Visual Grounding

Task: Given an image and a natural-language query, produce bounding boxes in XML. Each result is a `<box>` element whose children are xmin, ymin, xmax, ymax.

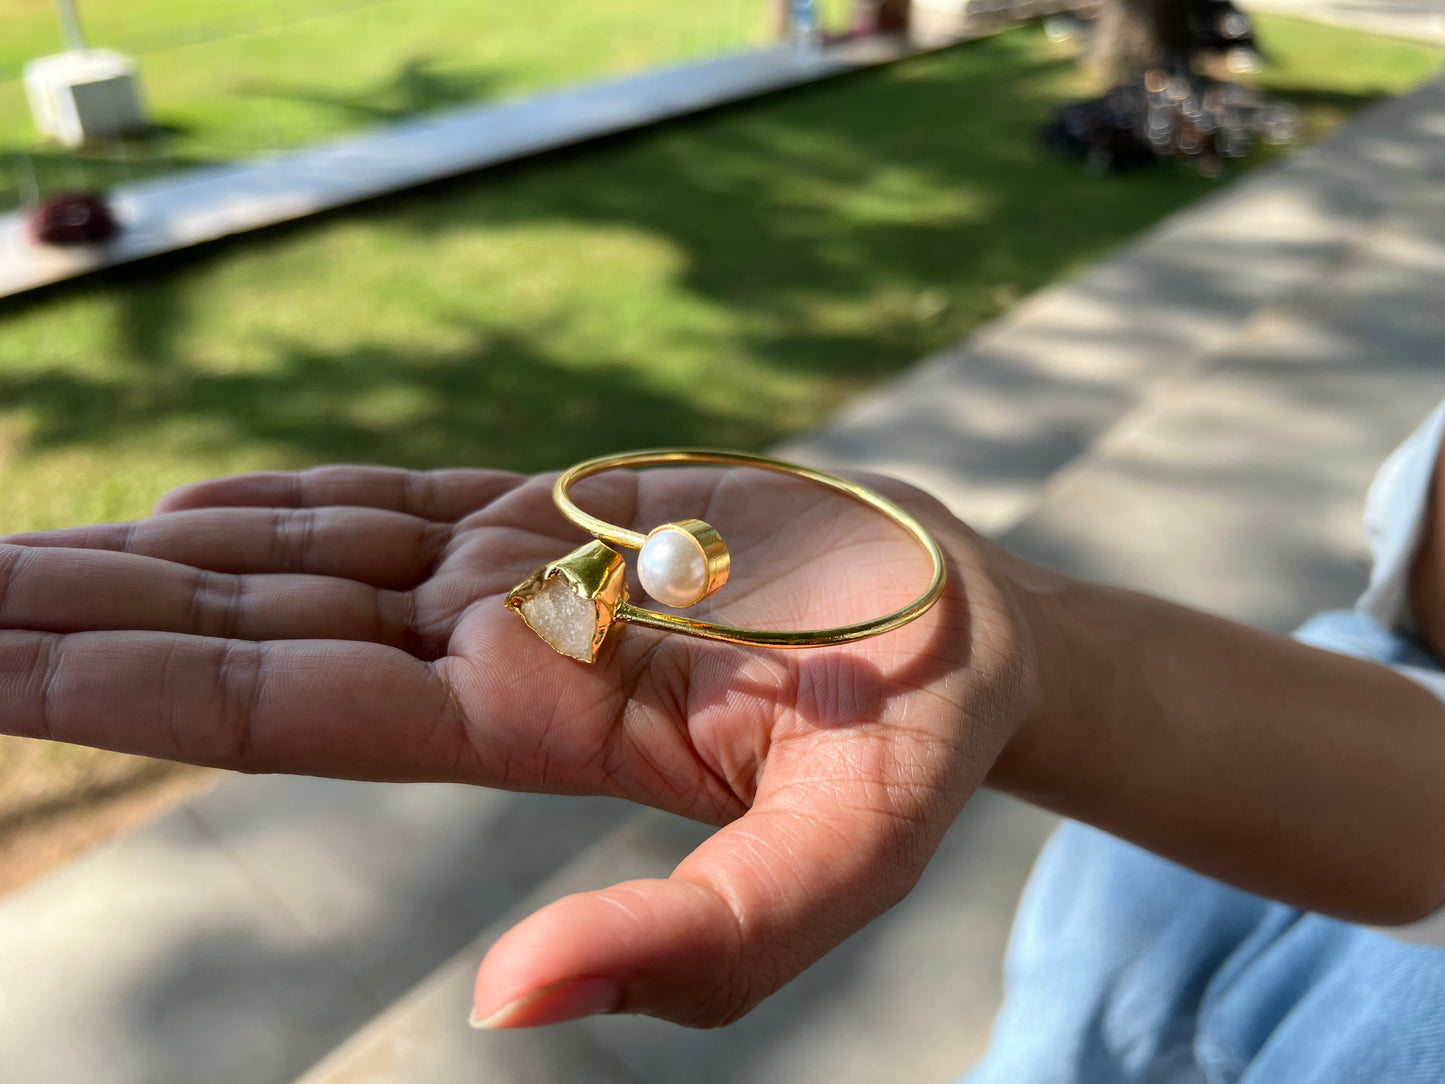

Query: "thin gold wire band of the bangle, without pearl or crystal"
<box><xmin>552</xmin><ymin>448</ymin><xmax>946</xmax><ymax>648</ymax></box>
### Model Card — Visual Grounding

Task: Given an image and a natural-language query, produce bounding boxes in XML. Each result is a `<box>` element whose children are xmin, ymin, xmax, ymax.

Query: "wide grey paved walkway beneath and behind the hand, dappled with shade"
<box><xmin>0</xmin><ymin>53</ymin><xmax>1445</xmax><ymax>1084</ymax></box>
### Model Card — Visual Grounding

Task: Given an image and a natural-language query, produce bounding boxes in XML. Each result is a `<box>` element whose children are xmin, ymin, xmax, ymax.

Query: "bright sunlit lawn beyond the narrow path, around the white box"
<box><xmin>0</xmin><ymin>0</ymin><xmax>847</xmax><ymax>210</ymax></box>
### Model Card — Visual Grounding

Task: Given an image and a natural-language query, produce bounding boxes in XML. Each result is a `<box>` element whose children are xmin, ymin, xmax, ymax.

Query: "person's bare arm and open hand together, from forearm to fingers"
<box><xmin>0</xmin><ymin>467</ymin><xmax>1445</xmax><ymax>1026</ymax></box>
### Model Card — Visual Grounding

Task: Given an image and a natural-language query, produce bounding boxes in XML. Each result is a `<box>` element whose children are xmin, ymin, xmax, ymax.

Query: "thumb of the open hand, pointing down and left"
<box><xmin>473</xmin><ymin>768</ymin><xmax>961</xmax><ymax>1028</ymax></box>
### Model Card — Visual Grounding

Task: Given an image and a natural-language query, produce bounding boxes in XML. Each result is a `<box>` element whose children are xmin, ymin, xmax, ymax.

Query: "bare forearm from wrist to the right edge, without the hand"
<box><xmin>991</xmin><ymin>562</ymin><xmax>1445</xmax><ymax>922</ymax></box>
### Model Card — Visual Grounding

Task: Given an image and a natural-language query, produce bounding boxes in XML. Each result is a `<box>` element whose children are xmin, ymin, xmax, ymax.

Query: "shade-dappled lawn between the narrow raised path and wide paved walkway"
<box><xmin>0</xmin><ymin>11</ymin><xmax>1442</xmax><ymax>529</ymax></box>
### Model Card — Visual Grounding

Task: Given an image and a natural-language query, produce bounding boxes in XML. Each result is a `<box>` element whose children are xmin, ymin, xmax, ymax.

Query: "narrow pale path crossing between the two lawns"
<box><xmin>0</xmin><ymin>38</ymin><xmax>924</xmax><ymax>296</ymax></box>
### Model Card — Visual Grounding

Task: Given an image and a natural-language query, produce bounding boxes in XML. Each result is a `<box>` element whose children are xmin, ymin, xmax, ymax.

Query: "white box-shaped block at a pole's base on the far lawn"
<box><xmin>25</xmin><ymin>49</ymin><xmax>146</xmax><ymax>147</ymax></box>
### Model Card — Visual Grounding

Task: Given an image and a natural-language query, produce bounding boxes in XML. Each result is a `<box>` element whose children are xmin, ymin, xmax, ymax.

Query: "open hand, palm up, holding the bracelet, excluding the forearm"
<box><xmin>0</xmin><ymin>467</ymin><xmax>1036</xmax><ymax>1026</ymax></box>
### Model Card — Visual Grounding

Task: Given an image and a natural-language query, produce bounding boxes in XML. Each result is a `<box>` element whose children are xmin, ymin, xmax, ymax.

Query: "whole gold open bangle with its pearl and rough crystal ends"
<box><xmin>507</xmin><ymin>448</ymin><xmax>946</xmax><ymax>662</ymax></box>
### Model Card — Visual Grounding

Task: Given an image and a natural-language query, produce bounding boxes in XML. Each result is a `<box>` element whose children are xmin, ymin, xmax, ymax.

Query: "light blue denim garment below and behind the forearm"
<box><xmin>965</xmin><ymin>613</ymin><xmax>1445</xmax><ymax>1084</ymax></box>
